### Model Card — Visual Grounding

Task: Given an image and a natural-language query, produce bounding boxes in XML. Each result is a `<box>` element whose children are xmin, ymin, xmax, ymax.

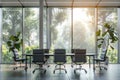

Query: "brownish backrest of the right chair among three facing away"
<box><xmin>74</xmin><ymin>49</ymin><xmax>86</xmax><ymax>62</ymax></box>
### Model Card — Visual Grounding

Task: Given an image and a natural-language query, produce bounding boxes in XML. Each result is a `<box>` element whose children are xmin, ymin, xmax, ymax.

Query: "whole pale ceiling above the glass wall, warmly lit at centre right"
<box><xmin>0</xmin><ymin>0</ymin><xmax>120</xmax><ymax>7</ymax></box>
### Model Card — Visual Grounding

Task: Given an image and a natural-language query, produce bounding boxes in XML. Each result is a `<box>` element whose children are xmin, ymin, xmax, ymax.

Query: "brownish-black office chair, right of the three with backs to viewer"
<box><xmin>73</xmin><ymin>49</ymin><xmax>87</xmax><ymax>73</ymax></box>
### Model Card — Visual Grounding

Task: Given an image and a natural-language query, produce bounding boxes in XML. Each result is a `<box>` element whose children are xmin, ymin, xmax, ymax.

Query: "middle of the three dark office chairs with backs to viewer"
<box><xmin>53</xmin><ymin>49</ymin><xmax>67</xmax><ymax>73</ymax></box>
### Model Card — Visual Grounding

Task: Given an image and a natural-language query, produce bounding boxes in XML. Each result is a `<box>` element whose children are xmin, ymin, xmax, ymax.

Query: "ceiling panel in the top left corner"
<box><xmin>0</xmin><ymin>0</ymin><xmax>21</xmax><ymax>6</ymax></box>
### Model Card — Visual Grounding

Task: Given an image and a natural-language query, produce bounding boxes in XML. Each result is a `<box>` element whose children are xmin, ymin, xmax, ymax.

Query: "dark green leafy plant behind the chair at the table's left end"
<box><xmin>7</xmin><ymin>32</ymin><xmax>22</xmax><ymax>52</ymax></box>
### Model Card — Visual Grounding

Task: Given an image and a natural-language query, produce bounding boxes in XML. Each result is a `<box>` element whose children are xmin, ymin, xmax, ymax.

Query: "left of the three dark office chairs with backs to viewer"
<box><xmin>32</xmin><ymin>49</ymin><xmax>46</xmax><ymax>73</ymax></box>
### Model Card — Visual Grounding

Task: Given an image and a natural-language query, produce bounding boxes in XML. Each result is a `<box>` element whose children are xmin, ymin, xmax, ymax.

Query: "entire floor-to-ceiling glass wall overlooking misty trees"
<box><xmin>0</xmin><ymin>7</ymin><xmax>119</xmax><ymax>63</ymax></box>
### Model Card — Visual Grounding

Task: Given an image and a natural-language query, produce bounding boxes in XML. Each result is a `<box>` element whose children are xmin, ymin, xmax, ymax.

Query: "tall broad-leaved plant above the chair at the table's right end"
<box><xmin>96</xmin><ymin>22</ymin><xmax>118</xmax><ymax>49</ymax></box>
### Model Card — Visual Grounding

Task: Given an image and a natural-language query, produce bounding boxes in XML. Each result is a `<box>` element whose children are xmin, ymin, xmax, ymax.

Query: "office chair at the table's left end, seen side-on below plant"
<box><xmin>12</xmin><ymin>49</ymin><xmax>26</xmax><ymax>70</ymax></box>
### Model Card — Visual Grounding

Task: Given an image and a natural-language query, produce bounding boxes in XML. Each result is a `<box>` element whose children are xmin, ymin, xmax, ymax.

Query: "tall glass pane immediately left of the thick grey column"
<box><xmin>23</xmin><ymin>8</ymin><xmax>39</xmax><ymax>54</ymax></box>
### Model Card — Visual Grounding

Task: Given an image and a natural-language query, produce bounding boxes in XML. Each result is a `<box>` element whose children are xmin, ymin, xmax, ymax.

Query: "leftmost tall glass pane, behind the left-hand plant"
<box><xmin>2</xmin><ymin>8</ymin><xmax>22</xmax><ymax>63</ymax></box>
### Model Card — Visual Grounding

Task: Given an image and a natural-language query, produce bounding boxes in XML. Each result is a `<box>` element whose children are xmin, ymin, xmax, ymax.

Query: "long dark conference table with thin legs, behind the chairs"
<box><xmin>25</xmin><ymin>53</ymin><xmax>95</xmax><ymax>71</ymax></box>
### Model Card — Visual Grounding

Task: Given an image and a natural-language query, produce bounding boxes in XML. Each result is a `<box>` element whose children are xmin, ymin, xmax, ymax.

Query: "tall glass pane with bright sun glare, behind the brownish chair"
<box><xmin>73</xmin><ymin>8</ymin><xmax>96</xmax><ymax>53</ymax></box>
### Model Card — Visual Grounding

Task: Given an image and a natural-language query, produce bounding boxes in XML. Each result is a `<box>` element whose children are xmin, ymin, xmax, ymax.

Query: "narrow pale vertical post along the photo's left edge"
<box><xmin>0</xmin><ymin>8</ymin><xmax>2</xmax><ymax>63</ymax></box>
